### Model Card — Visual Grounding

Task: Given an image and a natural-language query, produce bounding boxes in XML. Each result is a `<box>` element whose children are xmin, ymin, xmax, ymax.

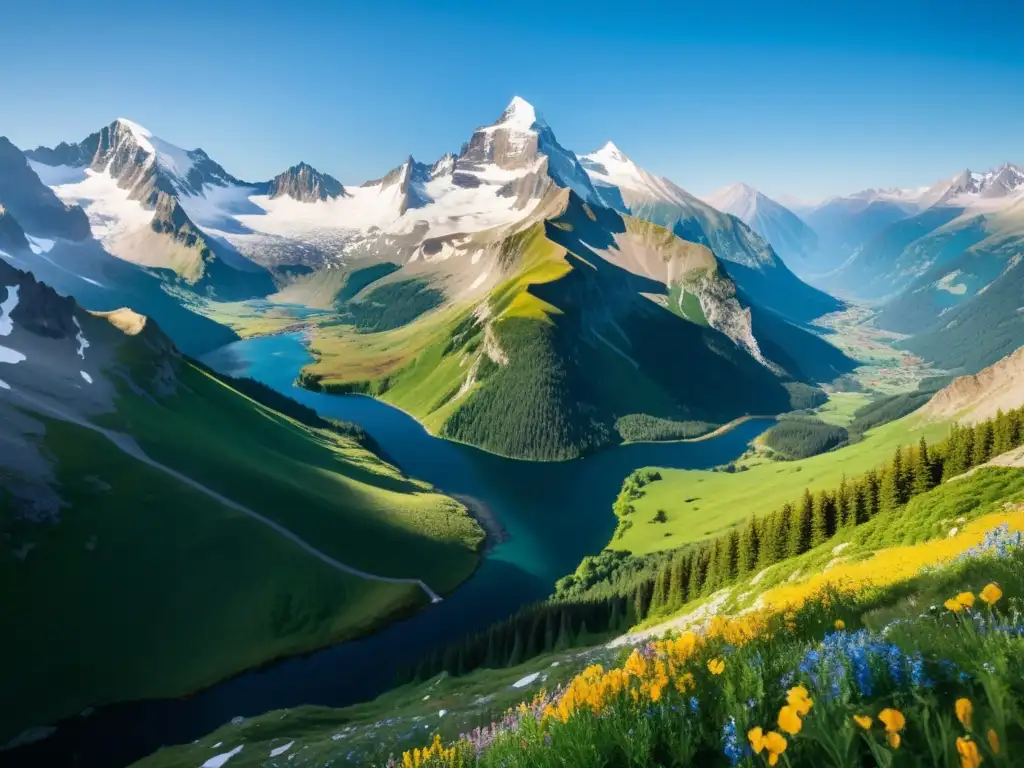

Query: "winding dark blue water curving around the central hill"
<box><xmin>8</xmin><ymin>334</ymin><xmax>771</xmax><ymax>768</ymax></box>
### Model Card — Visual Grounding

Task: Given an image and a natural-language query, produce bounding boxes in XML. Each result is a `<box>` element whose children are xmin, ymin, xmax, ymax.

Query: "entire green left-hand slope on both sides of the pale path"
<box><xmin>0</xmin><ymin>364</ymin><xmax>483</xmax><ymax>741</ymax></box>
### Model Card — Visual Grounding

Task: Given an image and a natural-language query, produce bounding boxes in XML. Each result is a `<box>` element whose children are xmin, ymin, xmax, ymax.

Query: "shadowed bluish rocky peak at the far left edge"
<box><xmin>0</xmin><ymin>136</ymin><xmax>90</xmax><ymax>240</ymax></box>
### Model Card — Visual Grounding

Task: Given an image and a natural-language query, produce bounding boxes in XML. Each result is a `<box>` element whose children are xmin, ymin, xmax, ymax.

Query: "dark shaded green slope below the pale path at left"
<box><xmin>0</xmin><ymin>421</ymin><xmax>415</xmax><ymax>741</ymax></box>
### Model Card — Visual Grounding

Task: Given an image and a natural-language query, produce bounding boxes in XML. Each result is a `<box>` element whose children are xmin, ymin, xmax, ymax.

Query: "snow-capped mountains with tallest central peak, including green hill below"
<box><xmin>0</xmin><ymin>97</ymin><xmax>854</xmax><ymax>466</ymax></box>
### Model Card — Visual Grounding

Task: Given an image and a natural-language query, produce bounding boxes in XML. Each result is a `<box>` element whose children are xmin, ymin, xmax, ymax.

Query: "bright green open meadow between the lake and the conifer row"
<box><xmin>608</xmin><ymin>415</ymin><xmax>948</xmax><ymax>554</ymax></box>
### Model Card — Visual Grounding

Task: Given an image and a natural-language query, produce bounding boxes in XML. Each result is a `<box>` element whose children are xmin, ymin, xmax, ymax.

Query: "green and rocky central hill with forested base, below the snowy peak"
<box><xmin>300</xmin><ymin>193</ymin><xmax>854</xmax><ymax>460</ymax></box>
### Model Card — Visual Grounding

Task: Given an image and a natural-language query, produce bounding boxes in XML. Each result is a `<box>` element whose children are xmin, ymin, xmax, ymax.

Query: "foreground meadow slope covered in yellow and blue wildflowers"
<box><xmin>137</xmin><ymin>462</ymin><xmax>1024</xmax><ymax>768</ymax></box>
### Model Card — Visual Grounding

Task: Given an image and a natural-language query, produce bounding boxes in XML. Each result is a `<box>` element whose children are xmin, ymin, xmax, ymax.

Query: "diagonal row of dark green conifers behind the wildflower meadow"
<box><xmin>399</xmin><ymin>408</ymin><xmax>1024</xmax><ymax>682</ymax></box>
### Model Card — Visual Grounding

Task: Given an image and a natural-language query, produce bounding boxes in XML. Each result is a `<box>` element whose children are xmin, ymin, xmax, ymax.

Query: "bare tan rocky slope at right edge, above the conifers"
<box><xmin>920</xmin><ymin>347</ymin><xmax>1024</xmax><ymax>424</ymax></box>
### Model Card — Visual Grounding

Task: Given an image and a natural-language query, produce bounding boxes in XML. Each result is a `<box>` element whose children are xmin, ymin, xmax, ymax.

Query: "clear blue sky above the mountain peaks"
<box><xmin>0</xmin><ymin>0</ymin><xmax>1024</xmax><ymax>199</ymax></box>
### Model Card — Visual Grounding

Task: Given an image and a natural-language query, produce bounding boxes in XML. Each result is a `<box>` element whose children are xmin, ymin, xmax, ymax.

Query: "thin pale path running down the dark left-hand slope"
<box><xmin>4</xmin><ymin>389</ymin><xmax>441</xmax><ymax>603</ymax></box>
